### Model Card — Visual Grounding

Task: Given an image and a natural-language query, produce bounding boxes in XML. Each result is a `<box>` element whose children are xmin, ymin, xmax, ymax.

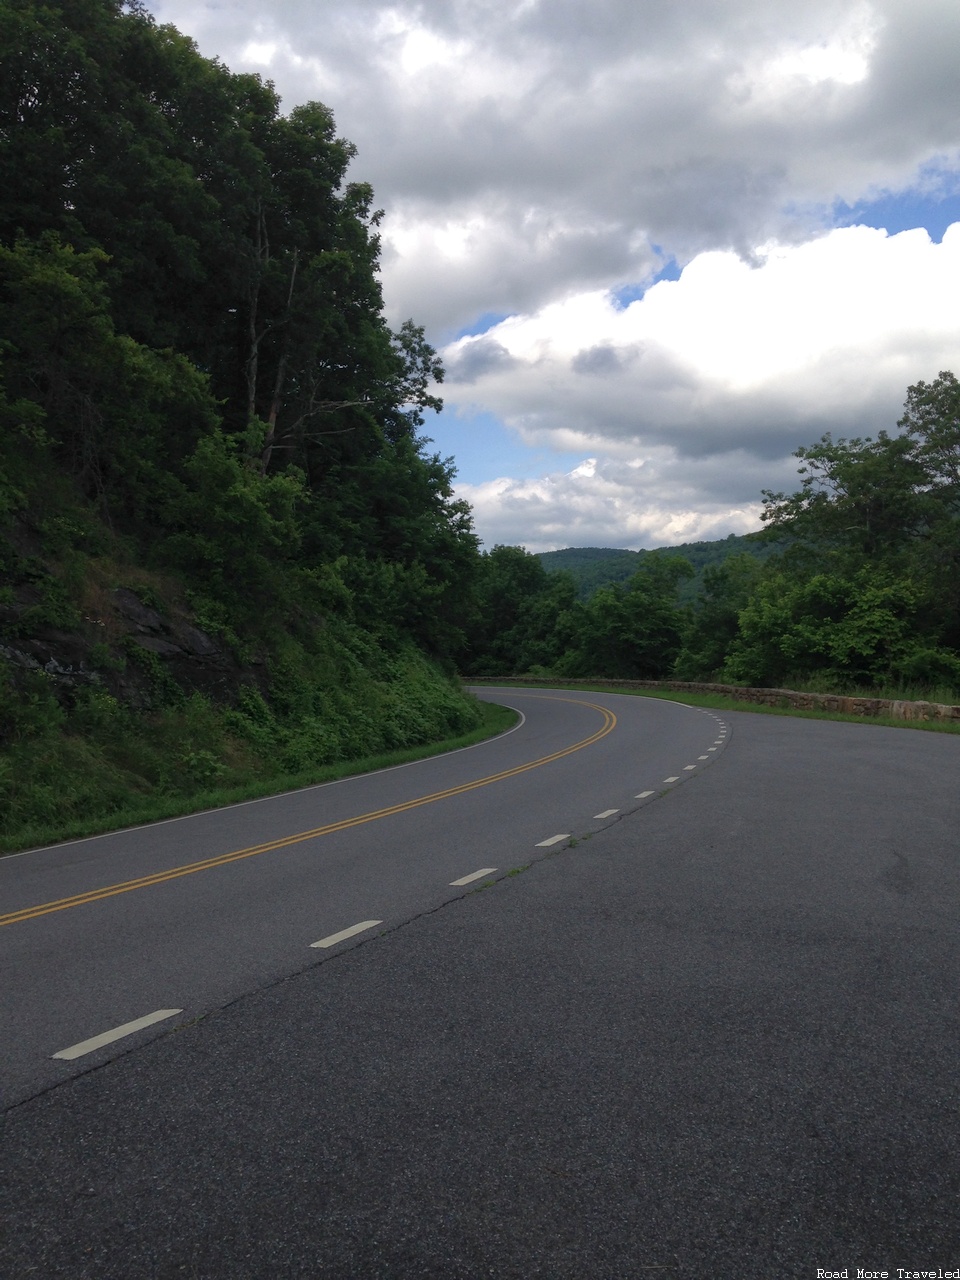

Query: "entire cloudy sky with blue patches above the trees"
<box><xmin>152</xmin><ymin>0</ymin><xmax>960</xmax><ymax>550</ymax></box>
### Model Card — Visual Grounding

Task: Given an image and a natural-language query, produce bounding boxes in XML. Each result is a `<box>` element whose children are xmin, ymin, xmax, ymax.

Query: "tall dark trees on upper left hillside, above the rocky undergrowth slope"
<box><xmin>0</xmin><ymin>0</ymin><xmax>475</xmax><ymax>640</ymax></box>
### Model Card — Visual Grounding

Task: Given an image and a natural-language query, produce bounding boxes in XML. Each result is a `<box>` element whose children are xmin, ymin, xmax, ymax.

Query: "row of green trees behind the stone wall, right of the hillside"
<box><xmin>458</xmin><ymin>371</ymin><xmax>960</xmax><ymax>695</ymax></box>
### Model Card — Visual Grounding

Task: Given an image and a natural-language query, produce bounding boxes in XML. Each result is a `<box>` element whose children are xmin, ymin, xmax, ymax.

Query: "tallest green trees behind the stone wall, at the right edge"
<box><xmin>724</xmin><ymin>372</ymin><xmax>960</xmax><ymax>686</ymax></box>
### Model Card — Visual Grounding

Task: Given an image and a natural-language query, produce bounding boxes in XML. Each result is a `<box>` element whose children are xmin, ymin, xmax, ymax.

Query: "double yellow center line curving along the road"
<box><xmin>0</xmin><ymin>694</ymin><xmax>617</xmax><ymax>927</ymax></box>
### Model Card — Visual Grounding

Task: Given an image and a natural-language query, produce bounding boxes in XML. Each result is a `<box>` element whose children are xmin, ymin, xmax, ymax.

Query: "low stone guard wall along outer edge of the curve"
<box><xmin>467</xmin><ymin>676</ymin><xmax>960</xmax><ymax>724</ymax></box>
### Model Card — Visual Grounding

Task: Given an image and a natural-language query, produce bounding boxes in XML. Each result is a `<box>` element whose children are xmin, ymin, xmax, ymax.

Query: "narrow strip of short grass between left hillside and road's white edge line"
<box><xmin>0</xmin><ymin>703</ymin><xmax>518</xmax><ymax>858</ymax></box>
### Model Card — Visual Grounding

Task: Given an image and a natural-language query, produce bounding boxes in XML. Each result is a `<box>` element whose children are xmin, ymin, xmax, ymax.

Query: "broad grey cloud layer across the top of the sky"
<box><xmin>148</xmin><ymin>0</ymin><xmax>960</xmax><ymax>332</ymax></box>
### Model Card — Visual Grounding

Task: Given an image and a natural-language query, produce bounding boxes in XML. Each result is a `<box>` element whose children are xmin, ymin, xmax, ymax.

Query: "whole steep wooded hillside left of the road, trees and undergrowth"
<box><xmin>0</xmin><ymin>0</ymin><xmax>477</xmax><ymax>844</ymax></box>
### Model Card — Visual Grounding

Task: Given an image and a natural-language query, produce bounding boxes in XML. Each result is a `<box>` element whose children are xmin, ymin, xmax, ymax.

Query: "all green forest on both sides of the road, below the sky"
<box><xmin>0</xmin><ymin>0</ymin><xmax>960</xmax><ymax>847</ymax></box>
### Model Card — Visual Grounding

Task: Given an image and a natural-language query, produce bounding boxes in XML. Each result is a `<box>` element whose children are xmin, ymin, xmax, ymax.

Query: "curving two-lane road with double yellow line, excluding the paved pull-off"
<box><xmin>0</xmin><ymin>691</ymin><xmax>724</xmax><ymax>1105</ymax></box>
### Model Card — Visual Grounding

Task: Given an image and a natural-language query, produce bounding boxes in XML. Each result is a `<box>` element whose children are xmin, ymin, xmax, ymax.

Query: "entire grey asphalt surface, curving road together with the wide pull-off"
<box><xmin>0</xmin><ymin>690</ymin><xmax>960</xmax><ymax>1280</ymax></box>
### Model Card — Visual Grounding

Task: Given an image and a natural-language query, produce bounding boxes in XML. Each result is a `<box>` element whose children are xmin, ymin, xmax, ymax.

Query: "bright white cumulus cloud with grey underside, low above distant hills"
<box><xmin>444</xmin><ymin>224</ymin><xmax>960</xmax><ymax>547</ymax></box>
